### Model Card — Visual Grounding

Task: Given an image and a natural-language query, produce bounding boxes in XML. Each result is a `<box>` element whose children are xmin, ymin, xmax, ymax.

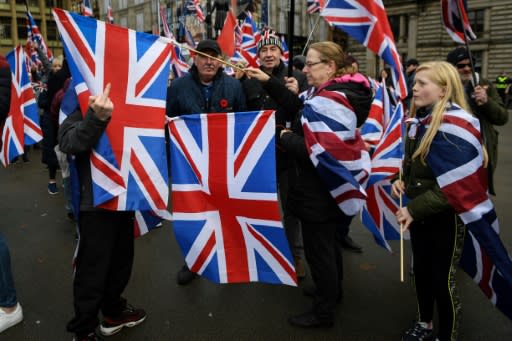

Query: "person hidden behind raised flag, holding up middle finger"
<box><xmin>59</xmin><ymin>83</ymin><xmax>146</xmax><ymax>341</ymax></box>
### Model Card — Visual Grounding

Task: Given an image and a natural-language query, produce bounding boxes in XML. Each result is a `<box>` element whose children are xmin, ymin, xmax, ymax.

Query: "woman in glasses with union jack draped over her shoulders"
<box><xmin>246</xmin><ymin>41</ymin><xmax>372</xmax><ymax>328</ymax></box>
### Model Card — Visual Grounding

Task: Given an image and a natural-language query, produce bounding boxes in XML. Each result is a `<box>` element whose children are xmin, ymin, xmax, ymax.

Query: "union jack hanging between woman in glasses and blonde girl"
<box><xmin>361</xmin><ymin>103</ymin><xmax>409</xmax><ymax>251</ymax></box>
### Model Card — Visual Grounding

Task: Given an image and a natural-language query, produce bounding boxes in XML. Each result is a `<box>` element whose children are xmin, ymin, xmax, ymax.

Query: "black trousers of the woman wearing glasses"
<box><xmin>301</xmin><ymin>216</ymin><xmax>352</xmax><ymax>322</ymax></box>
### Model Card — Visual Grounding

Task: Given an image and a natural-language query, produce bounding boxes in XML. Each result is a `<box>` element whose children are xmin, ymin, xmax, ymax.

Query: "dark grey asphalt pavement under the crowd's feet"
<box><xmin>0</xmin><ymin>123</ymin><xmax>512</xmax><ymax>341</ymax></box>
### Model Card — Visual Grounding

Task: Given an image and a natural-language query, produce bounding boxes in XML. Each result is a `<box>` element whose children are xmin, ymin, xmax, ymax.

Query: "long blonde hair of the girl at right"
<box><xmin>411</xmin><ymin>61</ymin><xmax>487</xmax><ymax>165</ymax></box>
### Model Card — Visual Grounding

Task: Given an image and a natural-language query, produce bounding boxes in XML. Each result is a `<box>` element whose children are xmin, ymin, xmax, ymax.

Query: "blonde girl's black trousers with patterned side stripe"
<box><xmin>410</xmin><ymin>212</ymin><xmax>464</xmax><ymax>340</ymax></box>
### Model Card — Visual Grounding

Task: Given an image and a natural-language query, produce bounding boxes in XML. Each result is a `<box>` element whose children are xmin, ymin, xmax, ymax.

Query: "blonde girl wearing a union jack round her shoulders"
<box><xmin>392</xmin><ymin>62</ymin><xmax>487</xmax><ymax>341</ymax></box>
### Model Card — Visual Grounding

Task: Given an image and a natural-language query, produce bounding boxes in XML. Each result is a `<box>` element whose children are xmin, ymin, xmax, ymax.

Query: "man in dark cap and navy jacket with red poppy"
<box><xmin>166</xmin><ymin>39</ymin><xmax>245</xmax><ymax>285</ymax></box>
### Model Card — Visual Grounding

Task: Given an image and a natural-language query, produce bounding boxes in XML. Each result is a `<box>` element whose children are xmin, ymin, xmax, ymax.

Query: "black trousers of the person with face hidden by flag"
<box><xmin>67</xmin><ymin>211</ymin><xmax>133</xmax><ymax>335</ymax></box>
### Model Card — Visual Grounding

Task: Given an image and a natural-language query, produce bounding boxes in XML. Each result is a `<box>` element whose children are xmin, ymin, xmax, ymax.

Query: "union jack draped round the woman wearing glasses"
<box><xmin>301</xmin><ymin>74</ymin><xmax>371</xmax><ymax>216</ymax></box>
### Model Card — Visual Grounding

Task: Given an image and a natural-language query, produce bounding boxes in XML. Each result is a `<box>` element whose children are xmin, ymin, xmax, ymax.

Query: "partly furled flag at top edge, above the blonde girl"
<box><xmin>441</xmin><ymin>0</ymin><xmax>476</xmax><ymax>44</ymax></box>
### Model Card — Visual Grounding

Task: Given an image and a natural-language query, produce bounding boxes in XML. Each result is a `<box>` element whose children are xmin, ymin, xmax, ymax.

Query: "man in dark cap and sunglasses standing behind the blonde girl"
<box><xmin>446</xmin><ymin>47</ymin><xmax>508</xmax><ymax>195</ymax></box>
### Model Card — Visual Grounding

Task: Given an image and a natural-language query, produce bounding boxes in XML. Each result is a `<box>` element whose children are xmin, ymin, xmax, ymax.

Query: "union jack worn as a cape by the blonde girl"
<box><xmin>424</xmin><ymin>105</ymin><xmax>512</xmax><ymax>319</ymax></box>
